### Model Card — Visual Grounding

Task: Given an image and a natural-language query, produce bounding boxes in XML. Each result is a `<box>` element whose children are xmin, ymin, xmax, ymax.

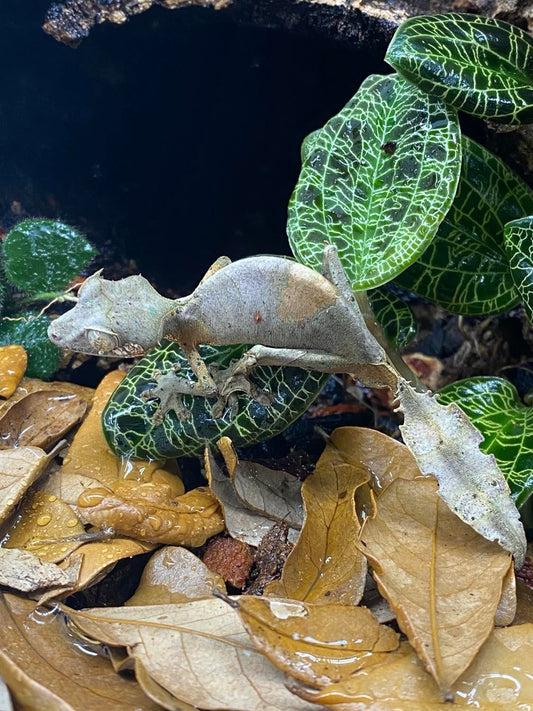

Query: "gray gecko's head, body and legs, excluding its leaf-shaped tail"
<box><xmin>48</xmin><ymin>249</ymin><xmax>390</xmax><ymax>398</ymax></box>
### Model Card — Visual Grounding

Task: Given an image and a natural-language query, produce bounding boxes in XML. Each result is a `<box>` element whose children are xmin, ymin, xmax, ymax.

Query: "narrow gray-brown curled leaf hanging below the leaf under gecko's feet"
<box><xmin>204</xmin><ymin>447</ymin><xmax>275</xmax><ymax>546</ymax></box>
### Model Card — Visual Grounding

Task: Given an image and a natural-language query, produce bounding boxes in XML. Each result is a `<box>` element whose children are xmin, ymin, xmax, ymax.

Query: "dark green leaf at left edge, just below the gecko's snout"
<box><xmin>0</xmin><ymin>311</ymin><xmax>61</xmax><ymax>380</ymax></box>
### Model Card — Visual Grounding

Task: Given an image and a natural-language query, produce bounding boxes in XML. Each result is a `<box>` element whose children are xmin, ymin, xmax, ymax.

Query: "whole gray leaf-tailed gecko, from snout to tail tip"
<box><xmin>49</xmin><ymin>246</ymin><xmax>526</xmax><ymax>567</ymax></box>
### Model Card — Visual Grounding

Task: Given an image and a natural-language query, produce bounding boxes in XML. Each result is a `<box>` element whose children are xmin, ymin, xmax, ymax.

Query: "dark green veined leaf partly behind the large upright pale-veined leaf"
<box><xmin>396</xmin><ymin>136</ymin><xmax>533</xmax><ymax>315</ymax></box>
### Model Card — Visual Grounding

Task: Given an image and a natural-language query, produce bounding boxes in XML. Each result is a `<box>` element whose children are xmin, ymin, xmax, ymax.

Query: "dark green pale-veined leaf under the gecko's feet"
<box><xmin>102</xmin><ymin>341</ymin><xmax>328</xmax><ymax>459</ymax></box>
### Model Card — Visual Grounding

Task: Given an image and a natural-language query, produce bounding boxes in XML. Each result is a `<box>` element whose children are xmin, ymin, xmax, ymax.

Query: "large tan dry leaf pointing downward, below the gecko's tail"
<box><xmin>361</xmin><ymin>477</ymin><xmax>512</xmax><ymax>694</ymax></box>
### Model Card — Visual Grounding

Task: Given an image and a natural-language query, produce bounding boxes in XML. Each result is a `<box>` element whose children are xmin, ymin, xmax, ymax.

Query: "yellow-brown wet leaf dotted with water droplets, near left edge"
<box><xmin>4</xmin><ymin>491</ymin><xmax>85</xmax><ymax>563</ymax></box>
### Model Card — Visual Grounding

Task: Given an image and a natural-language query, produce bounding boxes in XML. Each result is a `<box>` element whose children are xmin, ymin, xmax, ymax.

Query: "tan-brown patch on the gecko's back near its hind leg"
<box><xmin>278</xmin><ymin>269</ymin><xmax>337</xmax><ymax>323</ymax></box>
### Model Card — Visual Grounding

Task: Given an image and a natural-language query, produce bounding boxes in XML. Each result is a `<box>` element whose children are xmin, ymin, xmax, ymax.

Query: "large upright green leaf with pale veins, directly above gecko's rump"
<box><xmin>287</xmin><ymin>75</ymin><xmax>461</xmax><ymax>290</ymax></box>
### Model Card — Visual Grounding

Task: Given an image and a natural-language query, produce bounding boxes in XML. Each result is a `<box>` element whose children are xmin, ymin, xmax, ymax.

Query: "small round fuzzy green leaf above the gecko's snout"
<box><xmin>4</xmin><ymin>219</ymin><xmax>96</xmax><ymax>295</ymax></box>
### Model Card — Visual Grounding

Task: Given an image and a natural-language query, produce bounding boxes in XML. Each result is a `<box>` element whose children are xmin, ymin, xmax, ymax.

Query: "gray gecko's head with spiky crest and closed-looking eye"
<box><xmin>48</xmin><ymin>273</ymin><xmax>172</xmax><ymax>357</ymax></box>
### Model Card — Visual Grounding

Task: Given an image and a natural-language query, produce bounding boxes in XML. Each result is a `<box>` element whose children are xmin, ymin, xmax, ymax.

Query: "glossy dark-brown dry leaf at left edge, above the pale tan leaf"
<box><xmin>0</xmin><ymin>390</ymin><xmax>87</xmax><ymax>449</ymax></box>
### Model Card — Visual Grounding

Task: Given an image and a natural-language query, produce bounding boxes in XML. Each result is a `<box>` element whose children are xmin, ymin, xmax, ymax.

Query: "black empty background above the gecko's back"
<box><xmin>0</xmin><ymin>0</ymin><xmax>389</xmax><ymax>294</ymax></box>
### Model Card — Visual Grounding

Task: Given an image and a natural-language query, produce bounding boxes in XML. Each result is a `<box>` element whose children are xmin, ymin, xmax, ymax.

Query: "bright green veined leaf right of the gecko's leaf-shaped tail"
<box><xmin>438</xmin><ymin>377</ymin><xmax>533</xmax><ymax>506</ymax></box>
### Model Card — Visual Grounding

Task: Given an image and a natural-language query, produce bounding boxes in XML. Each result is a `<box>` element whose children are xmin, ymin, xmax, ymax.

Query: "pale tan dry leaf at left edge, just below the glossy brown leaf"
<box><xmin>0</xmin><ymin>447</ymin><xmax>56</xmax><ymax>523</ymax></box>
